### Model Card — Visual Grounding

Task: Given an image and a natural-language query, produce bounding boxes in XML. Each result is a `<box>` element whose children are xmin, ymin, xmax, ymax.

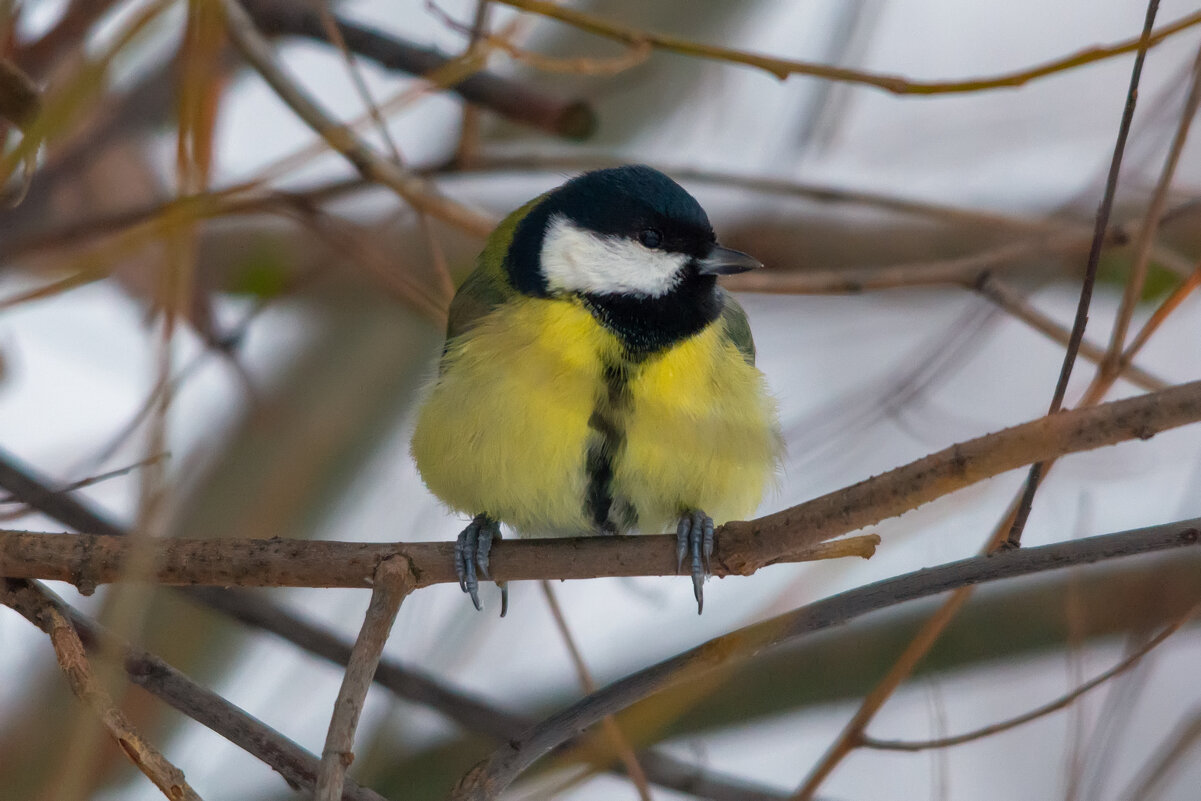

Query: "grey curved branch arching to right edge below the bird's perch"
<box><xmin>452</xmin><ymin>520</ymin><xmax>1201</xmax><ymax>801</ymax></box>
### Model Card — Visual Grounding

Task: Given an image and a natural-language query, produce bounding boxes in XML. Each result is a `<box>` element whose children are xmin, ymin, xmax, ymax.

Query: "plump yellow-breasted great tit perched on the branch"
<box><xmin>411</xmin><ymin>165</ymin><xmax>783</xmax><ymax>616</ymax></box>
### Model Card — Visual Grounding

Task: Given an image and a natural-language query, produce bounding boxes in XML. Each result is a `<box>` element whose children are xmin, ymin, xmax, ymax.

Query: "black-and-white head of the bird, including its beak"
<box><xmin>504</xmin><ymin>165</ymin><xmax>760</xmax><ymax>351</ymax></box>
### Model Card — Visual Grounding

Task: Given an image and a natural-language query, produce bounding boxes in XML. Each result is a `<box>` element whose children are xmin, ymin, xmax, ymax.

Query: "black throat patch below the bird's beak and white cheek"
<box><xmin>581</xmin><ymin>269</ymin><xmax>722</xmax><ymax>359</ymax></box>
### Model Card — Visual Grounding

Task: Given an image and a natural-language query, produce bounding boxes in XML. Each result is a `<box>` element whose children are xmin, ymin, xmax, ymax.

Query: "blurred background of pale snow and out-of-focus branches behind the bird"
<box><xmin>0</xmin><ymin>0</ymin><xmax>1201</xmax><ymax>801</ymax></box>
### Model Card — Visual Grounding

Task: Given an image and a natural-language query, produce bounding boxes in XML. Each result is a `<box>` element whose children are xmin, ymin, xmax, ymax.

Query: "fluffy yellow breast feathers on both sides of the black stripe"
<box><xmin>412</xmin><ymin>298</ymin><xmax>779</xmax><ymax>536</ymax></box>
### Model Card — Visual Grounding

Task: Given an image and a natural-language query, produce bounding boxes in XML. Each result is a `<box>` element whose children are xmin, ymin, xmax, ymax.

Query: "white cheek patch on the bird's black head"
<box><xmin>542</xmin><ymin>216</ymin><xmax>688</xmax><ymax>298</ymax></box>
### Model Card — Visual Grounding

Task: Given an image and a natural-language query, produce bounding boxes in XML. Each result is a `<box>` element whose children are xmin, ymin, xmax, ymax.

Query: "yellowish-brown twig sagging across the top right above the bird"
<box><xmin>497</xmin><ymin>0</ymin><xmax>1201</xmax><ymax>95</ymax></box>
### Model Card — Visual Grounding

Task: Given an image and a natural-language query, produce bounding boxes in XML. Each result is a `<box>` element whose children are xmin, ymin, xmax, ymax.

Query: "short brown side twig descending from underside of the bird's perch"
<box><xmin>313</xmin><ymin>557</ymin><xmax>412</xmax><ymax>801</ymax></box>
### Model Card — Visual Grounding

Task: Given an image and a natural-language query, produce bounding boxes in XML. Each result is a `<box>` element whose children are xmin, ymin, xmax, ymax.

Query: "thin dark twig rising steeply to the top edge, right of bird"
<box><xmin>1006</xmin><ymin>0</ymin><xmax>1159</xmax><ymax>548</ymax></box>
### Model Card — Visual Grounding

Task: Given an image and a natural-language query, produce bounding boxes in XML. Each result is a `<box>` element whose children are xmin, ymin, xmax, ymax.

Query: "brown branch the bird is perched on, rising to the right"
<box><xmin>7</xmin><ymin>381</ymin><xmax>1201</xmax><ymax>587</ymax></box>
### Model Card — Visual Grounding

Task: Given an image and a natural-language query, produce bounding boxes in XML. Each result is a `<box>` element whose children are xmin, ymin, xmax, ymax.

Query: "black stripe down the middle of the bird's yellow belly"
<box><xmin>584</xmin><ymin>363</ymin><xmax>637</xmax><ymax>534</ymax></box>
